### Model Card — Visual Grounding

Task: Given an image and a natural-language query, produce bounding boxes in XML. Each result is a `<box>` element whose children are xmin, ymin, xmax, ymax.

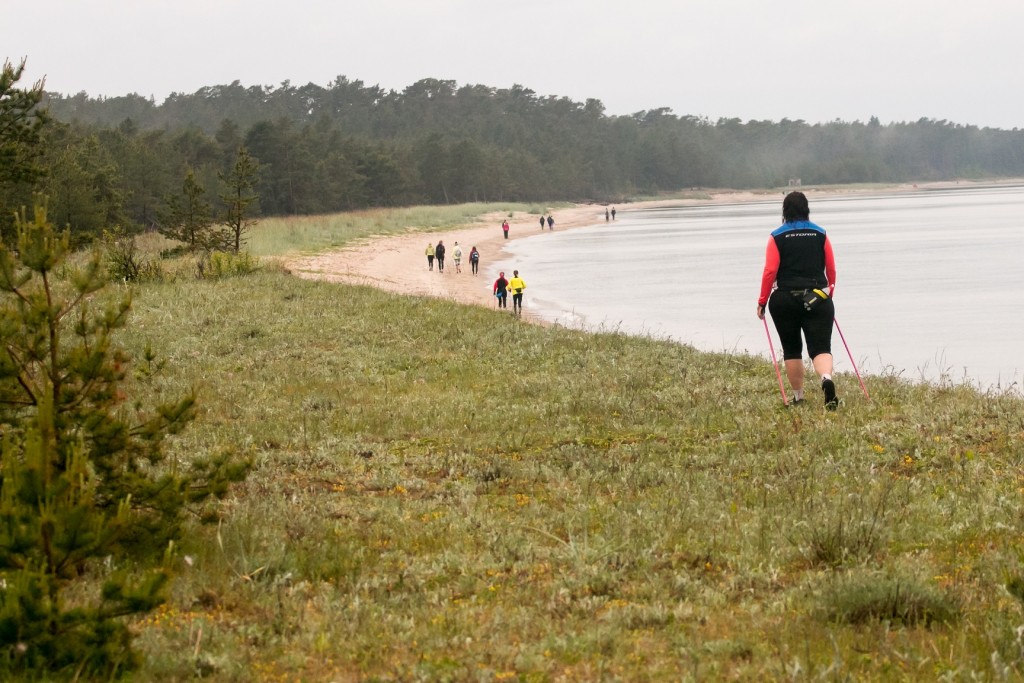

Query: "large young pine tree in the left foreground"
<box><xmin>0</xmin><ymin>198</ymin><xmax>248</xmax><ymax>678</ymax></box>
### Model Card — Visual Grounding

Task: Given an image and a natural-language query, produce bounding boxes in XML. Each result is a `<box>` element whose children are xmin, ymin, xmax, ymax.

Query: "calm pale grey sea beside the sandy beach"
<box><xmin>488</xmin><ymin>186</ymin><xmax>1024</xmax><ymax>390</ymax></box>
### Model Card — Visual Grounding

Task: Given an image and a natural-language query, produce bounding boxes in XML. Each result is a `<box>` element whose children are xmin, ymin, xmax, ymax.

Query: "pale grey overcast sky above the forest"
<box><xmin>0</xmin><ymin>0</ymin><xmax>1024</xmax><ymax>129</ymax></box>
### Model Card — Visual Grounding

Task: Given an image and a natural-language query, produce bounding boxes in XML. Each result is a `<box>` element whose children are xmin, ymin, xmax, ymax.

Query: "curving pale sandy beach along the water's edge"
<box><xmin>284</xmin><ymin>179</ymin><xmax>1024</xmax><ymax>325</ymax></box>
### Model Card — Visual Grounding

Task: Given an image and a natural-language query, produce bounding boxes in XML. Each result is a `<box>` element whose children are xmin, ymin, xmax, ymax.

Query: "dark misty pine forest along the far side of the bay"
<box><xmin>6</xmin><ymin>72</ymin><xmax>1024</xmax><ymax>241</ymax></box>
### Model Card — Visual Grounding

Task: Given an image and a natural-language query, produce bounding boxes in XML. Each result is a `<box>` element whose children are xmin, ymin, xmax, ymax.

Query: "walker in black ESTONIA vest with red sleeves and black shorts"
<box><xmin>757</xmin><ymin>191</ymin><xmax>839</xmax><ymax>411</ymax></box>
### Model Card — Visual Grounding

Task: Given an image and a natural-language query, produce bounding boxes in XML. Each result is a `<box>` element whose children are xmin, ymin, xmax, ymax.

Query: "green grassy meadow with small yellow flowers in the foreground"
<box><xmin>103</xmin><ymin>260</ymin><xmax>1024</xmax><ymax>681</ymax></box>
